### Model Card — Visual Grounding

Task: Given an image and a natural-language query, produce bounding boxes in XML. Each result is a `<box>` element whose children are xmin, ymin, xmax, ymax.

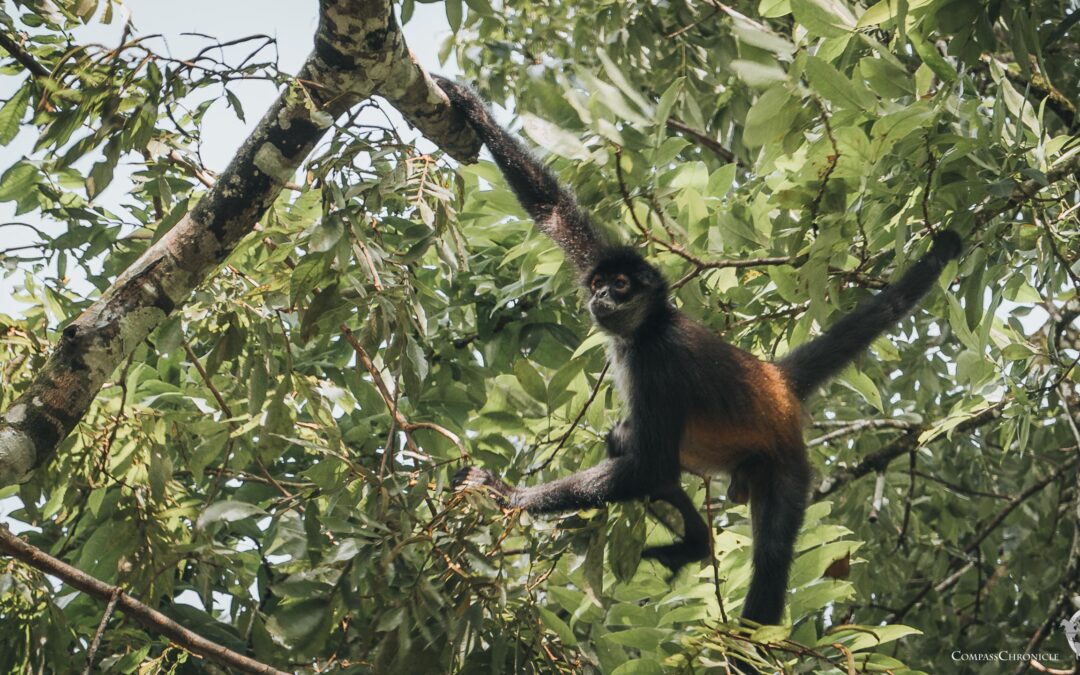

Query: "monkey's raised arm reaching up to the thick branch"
<box><xmin>435</xmin><ymin>77</ymin><xmax>605</xmax><ymax>274</ymax></box>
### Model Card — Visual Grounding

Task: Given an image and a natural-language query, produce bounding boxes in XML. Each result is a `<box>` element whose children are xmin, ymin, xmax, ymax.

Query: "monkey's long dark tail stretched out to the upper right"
<box><xmin>777</xmin><ymin>230</ymin><xmax>961</xmax><ymax>399</ymax></box>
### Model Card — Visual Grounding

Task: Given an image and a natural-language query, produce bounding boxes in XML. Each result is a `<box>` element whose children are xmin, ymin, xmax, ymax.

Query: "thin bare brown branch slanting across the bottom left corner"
<box><xmin>0</xmin><ymin>525</ymin><xmax>285</xmax><ymax>675</ymax></box>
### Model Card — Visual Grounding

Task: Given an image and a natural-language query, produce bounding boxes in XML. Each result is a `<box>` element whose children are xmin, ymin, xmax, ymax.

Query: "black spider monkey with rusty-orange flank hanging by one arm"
<box><xmin>437</xmin><ymin>78</ymin><xmax>961</xmax><ymax>624</ymax></box>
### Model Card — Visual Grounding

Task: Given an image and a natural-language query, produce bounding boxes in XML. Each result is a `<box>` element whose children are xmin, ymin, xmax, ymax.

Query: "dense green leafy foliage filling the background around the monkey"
<box><xmin>0</xmin><ymin>0</ymin><xmax>1080</xmax><ymax>675</ymax></box>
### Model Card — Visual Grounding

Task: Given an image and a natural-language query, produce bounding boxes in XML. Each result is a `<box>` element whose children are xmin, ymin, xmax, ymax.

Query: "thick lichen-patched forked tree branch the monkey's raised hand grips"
<box><xmin>0</xmin><ymin>0</ymin><xmax>480</xmax><ymax>486</ymax></box>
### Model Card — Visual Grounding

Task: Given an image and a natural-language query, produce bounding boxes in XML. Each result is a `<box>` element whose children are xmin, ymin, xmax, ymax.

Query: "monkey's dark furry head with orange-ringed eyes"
<box><xmin>585</xmin><ymin>246</ymin><xmax>670</xmax><ymax>337</ymax></box>
